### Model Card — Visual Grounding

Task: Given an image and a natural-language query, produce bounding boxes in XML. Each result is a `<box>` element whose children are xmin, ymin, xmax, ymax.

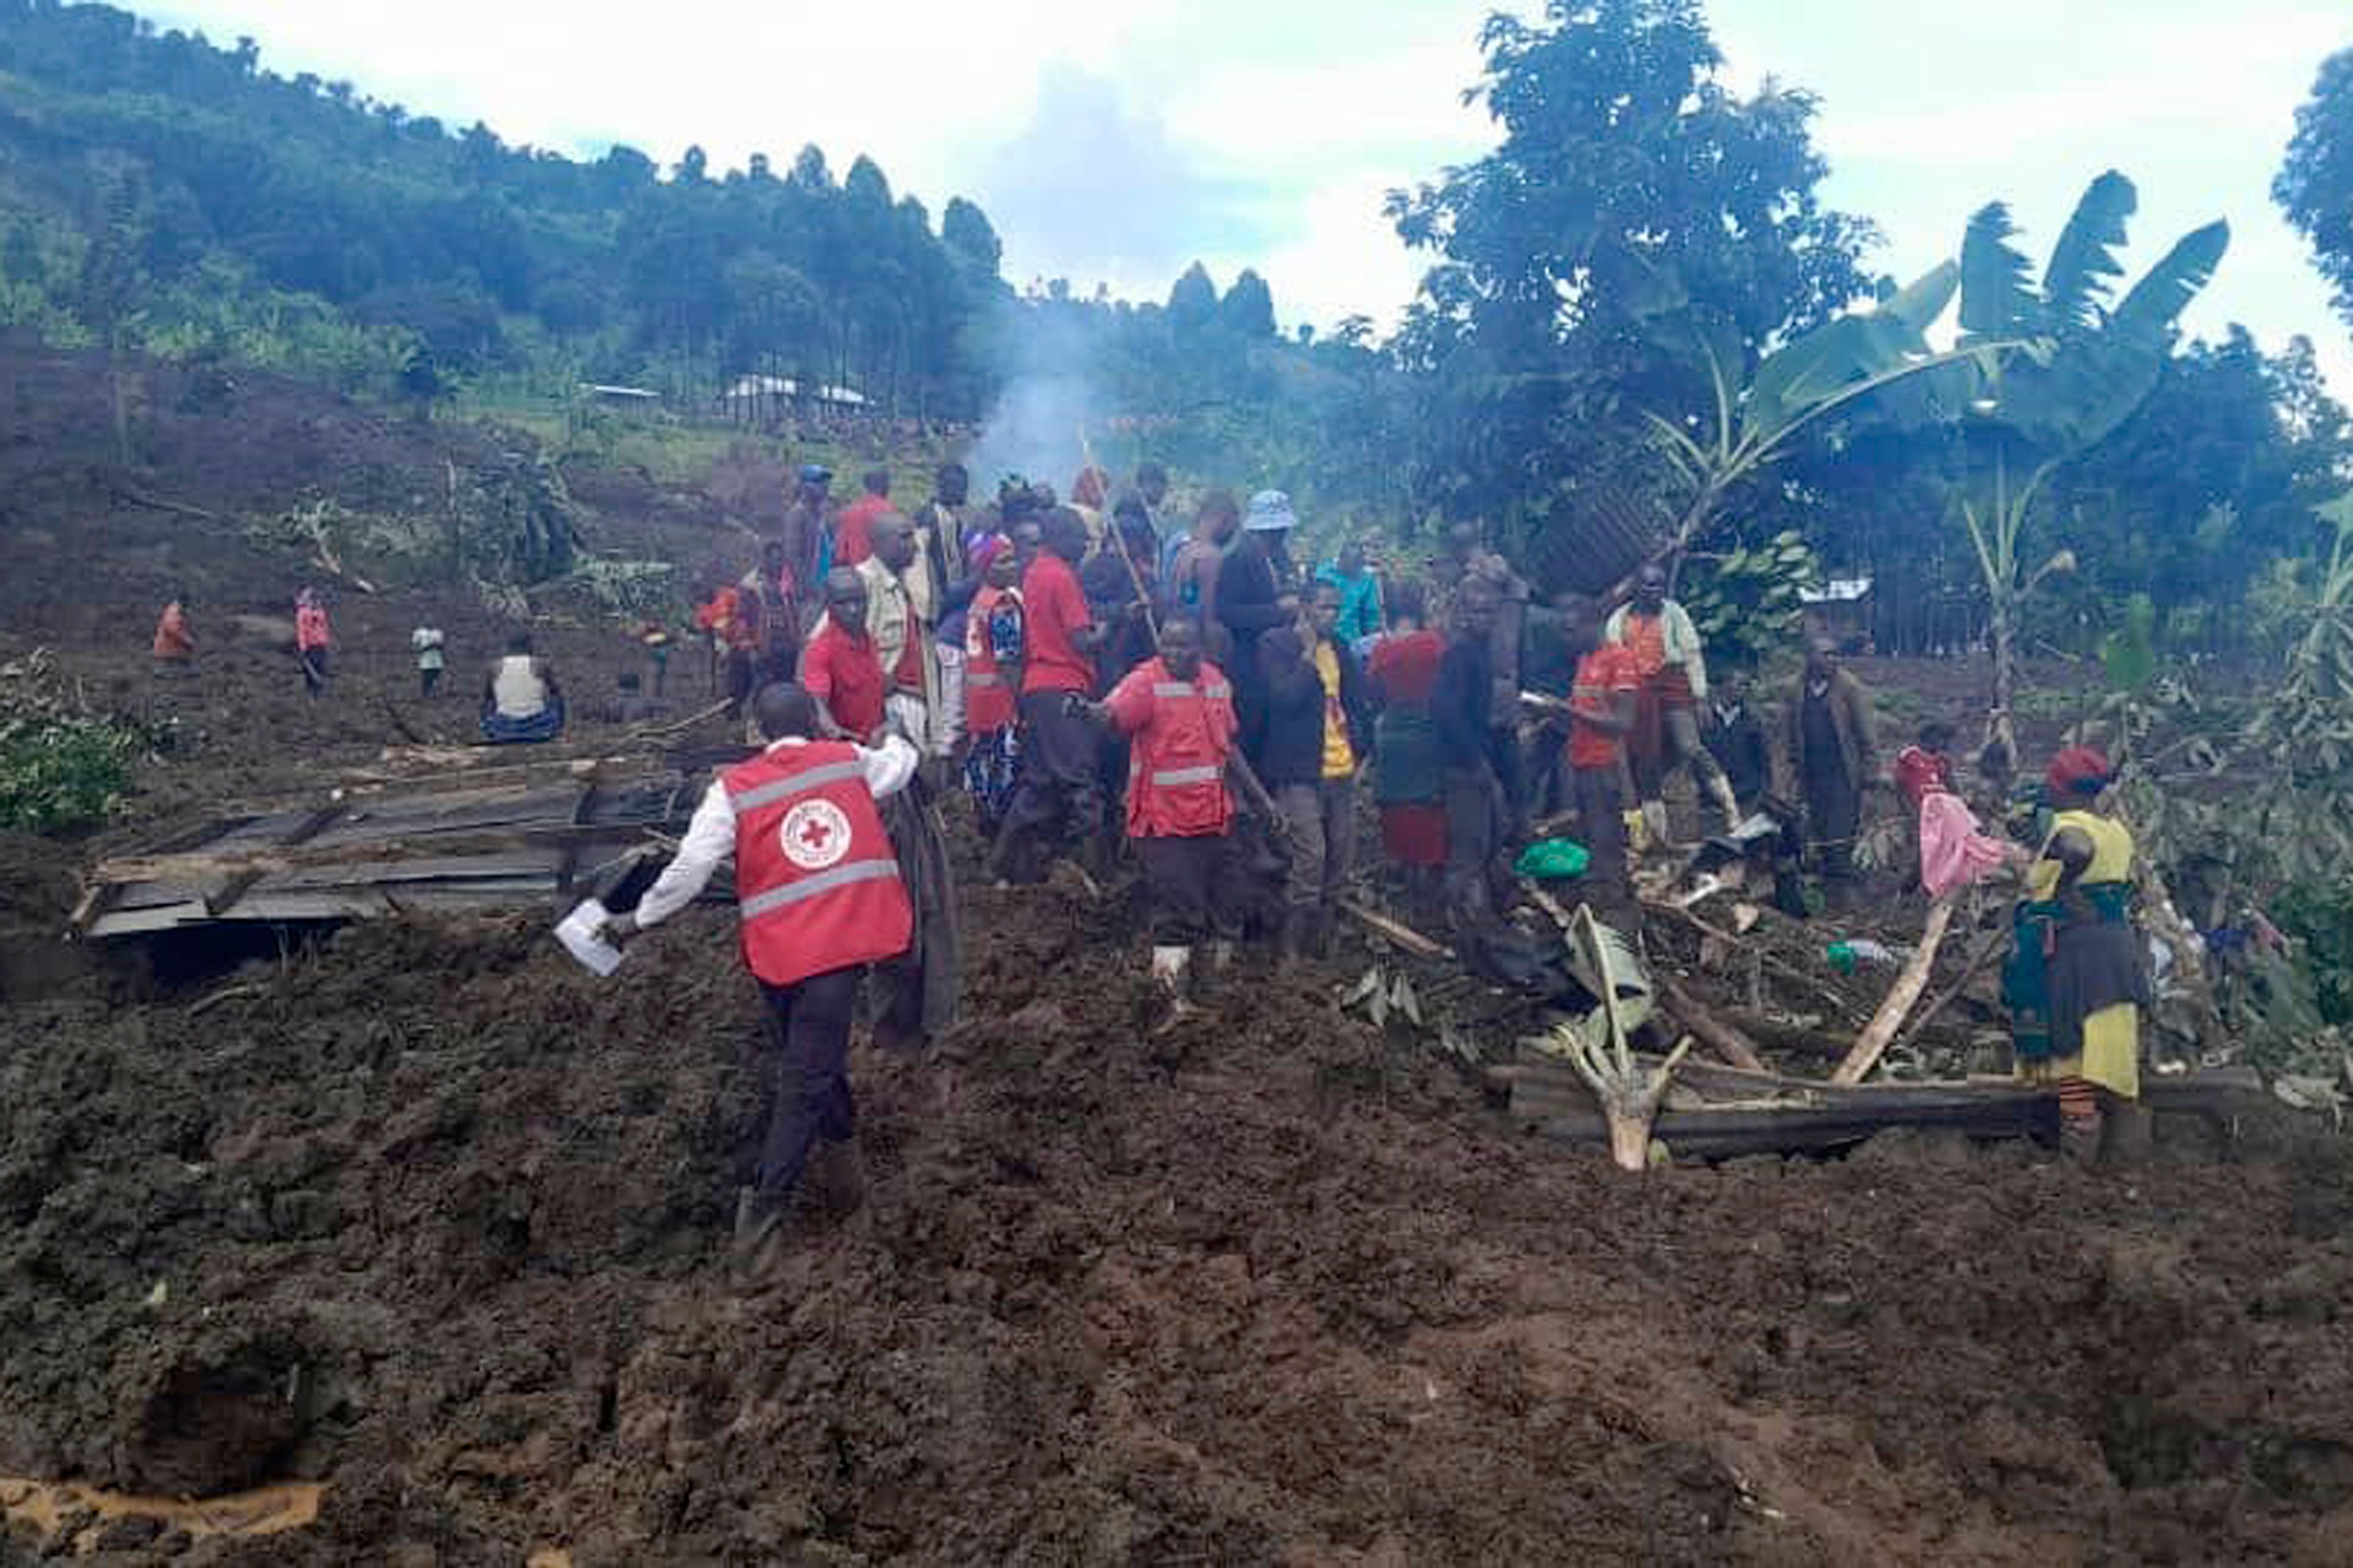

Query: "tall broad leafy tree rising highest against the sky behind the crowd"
<box><xmin>1389</xmin><ymin>0</ymin><xmax>1873</xmax><ymax>534</ymax></box>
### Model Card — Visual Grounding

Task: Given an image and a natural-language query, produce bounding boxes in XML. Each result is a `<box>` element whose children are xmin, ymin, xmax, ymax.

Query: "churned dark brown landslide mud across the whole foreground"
<box><xmin>0</xmin><ymin>346</ymin><xmax>2353</xmax><ymax>1563</ymax></box>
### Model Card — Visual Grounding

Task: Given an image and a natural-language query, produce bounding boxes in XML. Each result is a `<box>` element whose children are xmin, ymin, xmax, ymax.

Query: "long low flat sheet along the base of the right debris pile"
<box><xmin>1490</xmin><ymin>1048</ymin><xmax>2264</xmax><ymax>1161</ymax></box>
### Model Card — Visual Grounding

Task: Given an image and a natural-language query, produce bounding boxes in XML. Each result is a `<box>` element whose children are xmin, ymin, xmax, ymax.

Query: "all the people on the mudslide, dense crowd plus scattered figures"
<box><xmin>142</xmin><ymin>452</ymin><xmax>2143</xmax><ymax>1250</ymax></box>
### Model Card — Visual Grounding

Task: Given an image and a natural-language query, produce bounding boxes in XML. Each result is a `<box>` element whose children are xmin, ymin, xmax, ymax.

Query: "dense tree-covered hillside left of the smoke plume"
<box><xmin>0</xmin><ymin>0</ymin><xmax>1005</xmax><ymax>414</ymax></box>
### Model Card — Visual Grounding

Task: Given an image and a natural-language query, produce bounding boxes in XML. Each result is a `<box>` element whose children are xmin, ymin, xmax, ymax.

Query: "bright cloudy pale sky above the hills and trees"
<box><xmin>137</xmin><ymin>0</ymin><xmax>2353</xmax><ymax>400</ymax></box>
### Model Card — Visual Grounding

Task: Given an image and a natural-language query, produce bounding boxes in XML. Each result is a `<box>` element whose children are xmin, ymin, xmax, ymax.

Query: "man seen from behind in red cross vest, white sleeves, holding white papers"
<box><xmin>605</xmin><ymin>683</ymin><xmax>918</xmax><ymax>1274</ymax></box>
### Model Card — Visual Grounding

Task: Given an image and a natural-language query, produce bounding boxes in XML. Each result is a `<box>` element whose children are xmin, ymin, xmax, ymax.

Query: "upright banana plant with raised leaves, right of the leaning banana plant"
<box><xmin>1955</xmin><ymin>170</ymin><xmax>2230</xmax><ymax>758</ymax></box>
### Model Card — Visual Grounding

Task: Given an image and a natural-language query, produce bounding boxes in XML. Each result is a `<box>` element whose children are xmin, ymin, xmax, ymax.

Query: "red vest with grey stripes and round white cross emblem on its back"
<box><xmin>720</xmin><ymin>741</ymin><xmax>915</xmax><ymax>987</ymax></box>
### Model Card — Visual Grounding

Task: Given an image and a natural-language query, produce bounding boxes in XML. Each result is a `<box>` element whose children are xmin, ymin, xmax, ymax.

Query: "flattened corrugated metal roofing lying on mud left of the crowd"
<box><xmin>73</xmin><ymin>756</ymin><xmax>743</xmax><ymax>937</ymax></box>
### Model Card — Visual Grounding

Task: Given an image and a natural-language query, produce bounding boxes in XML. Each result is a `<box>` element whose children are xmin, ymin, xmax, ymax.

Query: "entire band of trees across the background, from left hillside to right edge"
<box><xmin>0</xmin><ymin>0</ymin><xmax>2353</xmax><ymax>654</ymax></box>
